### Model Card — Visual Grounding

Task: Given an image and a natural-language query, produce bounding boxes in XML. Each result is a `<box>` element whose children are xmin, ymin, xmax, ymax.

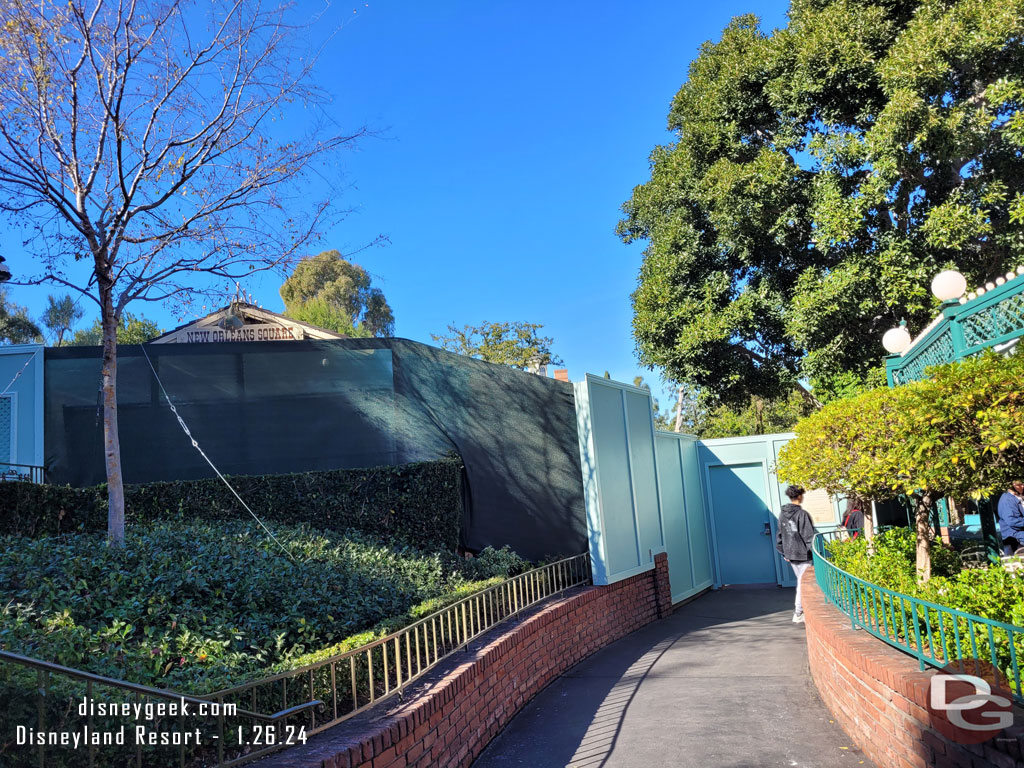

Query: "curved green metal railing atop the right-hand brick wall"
<box><xmin>812</xmin><ymin>531</ymin><xmax>1024</xmax><ymax>705</ymax></box>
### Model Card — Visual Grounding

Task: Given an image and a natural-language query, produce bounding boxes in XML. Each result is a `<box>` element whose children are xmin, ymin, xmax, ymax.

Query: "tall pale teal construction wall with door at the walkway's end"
<box><xmin>573</xmin><ymin>376</ymin><xmax>840</xmax><ymax>602</ymax></box>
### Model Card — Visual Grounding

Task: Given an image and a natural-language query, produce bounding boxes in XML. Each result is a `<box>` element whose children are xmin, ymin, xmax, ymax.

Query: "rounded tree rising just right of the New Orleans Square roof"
<box><xmin>281</xmin><ymin>251</ymin><xmax>394</xmax><ymax>336</ymax></box>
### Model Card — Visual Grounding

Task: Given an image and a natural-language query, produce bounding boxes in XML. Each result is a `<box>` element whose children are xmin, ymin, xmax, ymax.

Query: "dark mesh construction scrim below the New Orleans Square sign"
<box><xmin>44</xmin><ymin>339</ymin><xmax>587</xmax><ymax>559</ymax></box>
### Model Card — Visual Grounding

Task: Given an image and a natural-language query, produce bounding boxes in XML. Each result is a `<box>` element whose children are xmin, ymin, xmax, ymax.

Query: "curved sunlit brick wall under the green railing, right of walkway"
<box><xmin>803</xmin><ymin>569</ymin><xmax>1024</xmax><ymax>768</ymax></box>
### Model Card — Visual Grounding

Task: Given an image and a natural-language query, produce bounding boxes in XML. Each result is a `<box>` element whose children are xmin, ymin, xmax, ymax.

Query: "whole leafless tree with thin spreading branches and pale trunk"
<box><xmin>0</xmin><ymin>0</ymin><xmax>364</xmax><ymax>545</ymax></box>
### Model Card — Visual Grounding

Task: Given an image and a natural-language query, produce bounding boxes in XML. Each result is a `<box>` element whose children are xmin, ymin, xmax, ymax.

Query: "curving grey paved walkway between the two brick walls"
<box><xmin>473</xmin><ymin>588</ymin><xmax>873</xmax><ymax>768</ymax></box>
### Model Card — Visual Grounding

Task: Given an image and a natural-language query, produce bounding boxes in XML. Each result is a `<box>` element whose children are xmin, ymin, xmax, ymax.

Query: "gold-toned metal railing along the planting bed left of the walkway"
<box><xmin>0</xmin><ymin>553</ymin><xmax>591</xmax><ymax>768</ymax></box>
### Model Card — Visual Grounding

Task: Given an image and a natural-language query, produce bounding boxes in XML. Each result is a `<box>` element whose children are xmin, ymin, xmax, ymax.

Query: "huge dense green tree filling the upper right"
<box><xmin>617</xmin><ymin>0</ymin><xmax>1024</xmax><ymax>403</ymax></box>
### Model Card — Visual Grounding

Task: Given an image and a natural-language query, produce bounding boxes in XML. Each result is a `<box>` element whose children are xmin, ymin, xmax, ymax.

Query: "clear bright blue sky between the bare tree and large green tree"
<box><xmin>0</xmin><ymin>0</ymin><xmax>786</xmax><ymax>405</ymax></box>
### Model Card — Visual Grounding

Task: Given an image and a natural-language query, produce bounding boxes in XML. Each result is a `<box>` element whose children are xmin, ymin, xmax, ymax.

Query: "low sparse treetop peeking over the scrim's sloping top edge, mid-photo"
<box><xmin>430</xmin><ymin>323</ymin><xmax>562</xmax><ymax>371</ymax></box>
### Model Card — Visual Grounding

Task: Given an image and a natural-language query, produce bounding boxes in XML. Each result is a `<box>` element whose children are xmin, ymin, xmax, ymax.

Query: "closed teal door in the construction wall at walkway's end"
<box><xmin>707</xmin><ymin>462</ymin><xmax>777</xmax><ymax>584</ymax></box>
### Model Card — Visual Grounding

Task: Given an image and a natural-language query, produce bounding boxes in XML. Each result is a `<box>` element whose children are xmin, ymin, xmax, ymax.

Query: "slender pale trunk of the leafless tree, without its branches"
<box><xmin>100</xmin><ymin>288</ymin><xmax>125</xmax><ymax>547</ymax></box>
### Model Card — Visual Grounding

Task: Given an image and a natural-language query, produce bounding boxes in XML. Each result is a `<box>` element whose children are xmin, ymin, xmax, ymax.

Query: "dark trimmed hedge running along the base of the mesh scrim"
<box><xmin>0</xmin><ymin>458</ymin><xmax>462</xmax><ymax>549</ymax></box>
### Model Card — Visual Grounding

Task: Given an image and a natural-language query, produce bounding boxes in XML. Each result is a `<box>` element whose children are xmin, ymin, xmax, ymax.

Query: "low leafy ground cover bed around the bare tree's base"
<box><xmin>0</xmin><ymin>517</ymin><xmax>521</xmax><ymax>692</ymax></box>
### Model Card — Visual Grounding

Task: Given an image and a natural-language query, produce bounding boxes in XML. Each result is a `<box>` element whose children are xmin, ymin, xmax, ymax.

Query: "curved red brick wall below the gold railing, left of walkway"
<box><xmin>255</xmin><ymin>554</ymin><xmax>672</xmax><ymax>768</ymax></box>
